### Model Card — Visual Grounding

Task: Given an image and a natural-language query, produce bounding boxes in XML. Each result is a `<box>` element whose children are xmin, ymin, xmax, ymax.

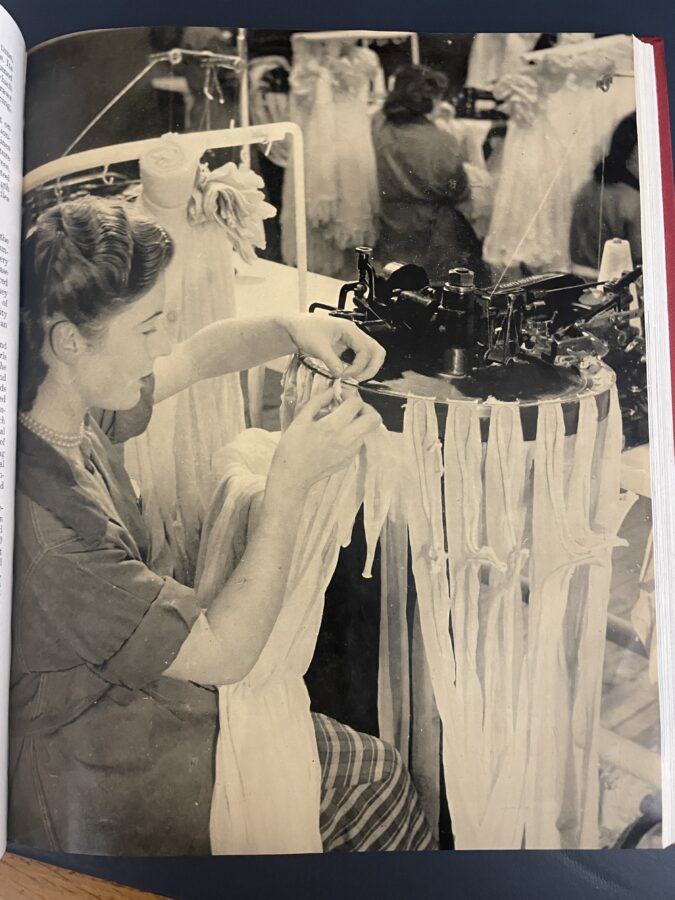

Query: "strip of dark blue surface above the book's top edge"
<box><xmin>2</xmin><ymin>0</ymin><xmax>675</xmax><ymax>137</ymax></box>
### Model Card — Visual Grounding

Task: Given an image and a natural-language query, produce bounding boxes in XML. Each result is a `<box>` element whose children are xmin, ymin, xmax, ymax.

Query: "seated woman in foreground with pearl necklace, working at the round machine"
<box><xmin>9</xmin><ymin>198</ymin><xmax>431</xmax><ymax>855</ymax></box>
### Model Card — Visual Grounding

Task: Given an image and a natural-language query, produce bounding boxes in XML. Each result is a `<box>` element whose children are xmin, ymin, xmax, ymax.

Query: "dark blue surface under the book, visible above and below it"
<box><xmin>3</xmin><ymin>0</ymin><xmax>675</xmax><ymax>900</ymax></box>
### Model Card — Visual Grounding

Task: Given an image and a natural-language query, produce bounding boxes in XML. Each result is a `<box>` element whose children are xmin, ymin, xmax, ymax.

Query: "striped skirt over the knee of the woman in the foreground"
<box><xmin>312</xmin><ymin>713</ymin><xmax>436</xmax><ymax>853</ymax></box>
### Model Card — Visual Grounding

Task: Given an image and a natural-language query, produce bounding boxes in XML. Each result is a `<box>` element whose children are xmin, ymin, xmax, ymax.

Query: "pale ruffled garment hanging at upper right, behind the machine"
<box><xmin>484</xmin><ymin>37</ymin><xmax>635</xmax><ymax>274</ymax></box>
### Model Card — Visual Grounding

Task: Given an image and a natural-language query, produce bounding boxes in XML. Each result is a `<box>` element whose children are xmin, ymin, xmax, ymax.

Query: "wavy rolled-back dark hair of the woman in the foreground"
<box><xmin>19</xmin><ymin>197</ymin><xmax>173</xmax><ymax>412</ymax></box>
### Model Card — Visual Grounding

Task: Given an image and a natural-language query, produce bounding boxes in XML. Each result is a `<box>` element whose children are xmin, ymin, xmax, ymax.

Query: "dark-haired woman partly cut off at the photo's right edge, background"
<box><xmin>570</xmin><ymin>113</ymin><xmax>642</xmax><ymax>271</ymax></box>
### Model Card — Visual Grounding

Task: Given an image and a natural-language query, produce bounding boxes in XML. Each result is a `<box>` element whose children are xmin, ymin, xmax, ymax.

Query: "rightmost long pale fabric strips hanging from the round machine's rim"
<box><xmin>526</xmin><ymin>388</ymin><xmax>635</xmax><ymax>848</ymax></box>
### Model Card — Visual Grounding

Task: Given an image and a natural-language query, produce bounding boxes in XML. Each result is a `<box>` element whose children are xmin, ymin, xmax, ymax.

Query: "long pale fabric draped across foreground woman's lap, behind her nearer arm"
<box><xmin>197</xmin><ymin>371</ymin><xmax>402</xmax><ymax>854</ymax></box>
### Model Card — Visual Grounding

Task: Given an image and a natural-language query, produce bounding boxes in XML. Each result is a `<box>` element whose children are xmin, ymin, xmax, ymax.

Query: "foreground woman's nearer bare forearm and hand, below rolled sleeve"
<box><xmin>165</xmin><ymin>390</ymin><xmax>381</xmax><ymax>684</ymax></box>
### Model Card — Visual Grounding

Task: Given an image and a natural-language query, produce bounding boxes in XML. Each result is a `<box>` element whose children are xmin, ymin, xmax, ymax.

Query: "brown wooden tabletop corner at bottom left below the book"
<box><xmin>0</xmin><ymin>853</ymin><xmax>165</xmax><ymax>900</ymax></box>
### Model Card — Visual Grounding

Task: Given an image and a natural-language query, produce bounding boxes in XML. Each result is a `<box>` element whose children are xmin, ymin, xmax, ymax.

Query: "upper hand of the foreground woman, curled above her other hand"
<box><xmin>285</xmin><ymin>313</ymin><xmax>385</xmax><ymax>381</ymax></box>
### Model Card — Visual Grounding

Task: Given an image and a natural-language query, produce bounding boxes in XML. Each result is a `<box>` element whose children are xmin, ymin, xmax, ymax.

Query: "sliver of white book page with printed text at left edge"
<box><xmin>0</xmin><ymin>1</ymin><xmax>26</xmax><ymax>853</ymax></box>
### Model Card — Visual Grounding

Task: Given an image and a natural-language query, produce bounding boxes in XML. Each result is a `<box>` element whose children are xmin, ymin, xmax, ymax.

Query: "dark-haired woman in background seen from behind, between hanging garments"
<box><xmin>373</xmin><ymin>66</ymin><xmax>482</xmax><ymax>281</ymax></box>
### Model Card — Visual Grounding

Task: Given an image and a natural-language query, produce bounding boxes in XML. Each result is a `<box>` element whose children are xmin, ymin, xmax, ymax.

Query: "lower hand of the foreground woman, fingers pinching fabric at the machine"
<box><xmin>268</xmin><ymin>388</ymin><xmax>382</xmax><ymax>493</ymax></box>
